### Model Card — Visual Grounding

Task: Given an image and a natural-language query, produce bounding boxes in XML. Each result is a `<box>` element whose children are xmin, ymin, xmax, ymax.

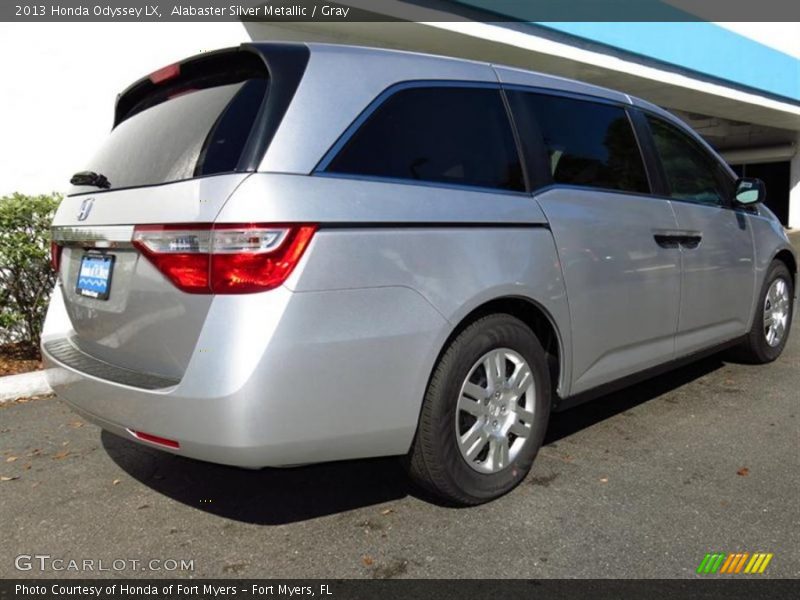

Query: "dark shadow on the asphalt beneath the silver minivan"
<box><xmin>101</xmin><ymin>356</ymin><xmax>724</xmax><ymax>525</ymax></box>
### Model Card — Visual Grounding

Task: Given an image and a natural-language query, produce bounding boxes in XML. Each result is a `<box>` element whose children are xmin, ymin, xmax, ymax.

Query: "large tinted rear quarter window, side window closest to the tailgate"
<box><xmin>327</xmin><ymin>87</ymin><xmax>525</xmax><ymax>190</ymax></box>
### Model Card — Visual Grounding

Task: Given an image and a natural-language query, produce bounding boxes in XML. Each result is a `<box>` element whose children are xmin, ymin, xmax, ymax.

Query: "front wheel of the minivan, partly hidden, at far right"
<box><xmin>736</xmin><ymin>260</ymin><xmax>794</xmax><ymax>364</ymax></box>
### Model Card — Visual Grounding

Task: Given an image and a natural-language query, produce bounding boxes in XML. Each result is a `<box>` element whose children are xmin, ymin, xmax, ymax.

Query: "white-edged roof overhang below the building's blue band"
<box><xmin>245</xmin><ymin>16</ymin><xmax>800</xmax><ymax>131</ymax></box>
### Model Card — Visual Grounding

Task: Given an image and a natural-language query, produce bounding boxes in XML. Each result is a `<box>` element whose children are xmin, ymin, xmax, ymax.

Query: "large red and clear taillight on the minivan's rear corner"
<box><xmin>133</xmin><ymin>223</ymin><xmax>317</xmax><ymax>294</ymax></box>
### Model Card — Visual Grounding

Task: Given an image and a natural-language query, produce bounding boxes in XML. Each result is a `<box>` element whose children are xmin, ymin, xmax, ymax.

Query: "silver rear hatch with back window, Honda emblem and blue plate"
<box><xmin>53</xmin><ymin>46</ymin><xmax>304</xmax><ymax>379</ymax></box>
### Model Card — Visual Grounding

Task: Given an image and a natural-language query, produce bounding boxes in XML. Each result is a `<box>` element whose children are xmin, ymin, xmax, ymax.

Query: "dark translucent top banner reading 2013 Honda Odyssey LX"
<box><xmin>0</xmin><ymin>0</ymin><xmax>800</xmax><ymax>23</ymax></box>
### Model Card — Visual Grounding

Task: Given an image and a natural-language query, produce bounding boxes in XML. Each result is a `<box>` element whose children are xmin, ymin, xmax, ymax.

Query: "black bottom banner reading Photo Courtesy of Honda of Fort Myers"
<box><xmin>0</xmin><ymin>577</ymin><xmax>800</xmax><ymax>600</ymax></box>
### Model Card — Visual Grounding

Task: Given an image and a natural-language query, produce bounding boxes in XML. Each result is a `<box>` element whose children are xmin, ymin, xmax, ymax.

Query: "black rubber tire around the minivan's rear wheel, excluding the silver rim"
<box><xmin>406</xmin><ymin>314</ymin><xmax>551</xmax><ymax>506</ymax></box>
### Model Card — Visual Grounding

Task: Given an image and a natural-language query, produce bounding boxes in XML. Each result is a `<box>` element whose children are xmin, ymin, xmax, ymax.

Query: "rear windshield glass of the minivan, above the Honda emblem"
<box><xmin>76</xmin><ymin>54</ymin><xmax>267</xmax><ymax>189</ymax></box>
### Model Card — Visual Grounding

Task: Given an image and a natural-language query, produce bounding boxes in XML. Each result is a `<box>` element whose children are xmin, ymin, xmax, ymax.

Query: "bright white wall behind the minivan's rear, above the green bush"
<box><xmin>0</xmin><ymin>22</ymin><xmax>248</xmax><ymax>196</ymax></box>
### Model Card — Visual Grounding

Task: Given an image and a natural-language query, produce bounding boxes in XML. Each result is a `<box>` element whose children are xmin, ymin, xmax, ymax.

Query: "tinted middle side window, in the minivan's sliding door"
<box><xmin>509</xmin><ymin>91</ymin><xmax>650</xmax><ymax>193</ymax></box>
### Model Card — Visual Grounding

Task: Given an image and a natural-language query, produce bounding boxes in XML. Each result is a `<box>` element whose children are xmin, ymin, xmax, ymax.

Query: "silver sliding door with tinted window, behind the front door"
<box><xmin>507</xmin><ymin>89</ymin><xmax>680</xmax><ymax>394</ymax></box>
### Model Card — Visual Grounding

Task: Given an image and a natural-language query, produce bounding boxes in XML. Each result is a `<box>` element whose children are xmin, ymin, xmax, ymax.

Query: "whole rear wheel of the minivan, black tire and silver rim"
<box><xmin>407</xmin><ymin>314</ymin><xmax>550</xmax><ymax>505</ymax></box>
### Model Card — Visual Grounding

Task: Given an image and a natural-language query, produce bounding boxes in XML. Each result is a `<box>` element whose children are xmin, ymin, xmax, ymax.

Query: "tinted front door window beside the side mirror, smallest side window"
<box><xmin>647</xmin><ymin>115</ymin><xmax>728</xmax><ymax>204</ymax></box>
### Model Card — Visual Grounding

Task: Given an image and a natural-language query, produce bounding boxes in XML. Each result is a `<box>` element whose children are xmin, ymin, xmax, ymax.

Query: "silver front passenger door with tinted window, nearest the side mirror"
<box><xmin>646</xmin><ymin>115</ymin><xmax>755</xmax><ymax>355</ymax></box>
